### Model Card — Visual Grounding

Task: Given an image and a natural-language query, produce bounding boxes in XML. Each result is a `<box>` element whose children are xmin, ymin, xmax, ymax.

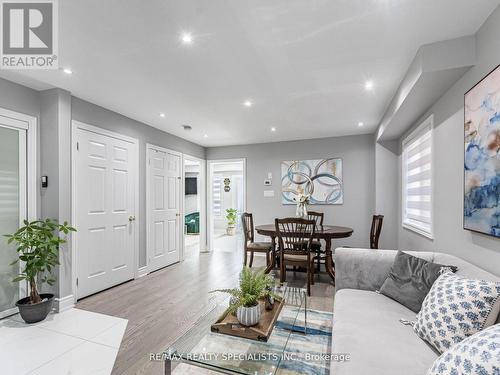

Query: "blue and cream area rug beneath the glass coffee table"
<box><xmin>174</xmin><ymin>306</ymin><xmax>333</xmax><ymax>375</ymax></box>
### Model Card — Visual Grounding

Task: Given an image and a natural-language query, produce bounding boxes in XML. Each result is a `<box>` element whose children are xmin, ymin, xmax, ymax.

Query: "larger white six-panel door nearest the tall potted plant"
<box><xmin>74</xmin><ymin>124</ymin><xmax>138</xmax><ymax>298</ymax></box>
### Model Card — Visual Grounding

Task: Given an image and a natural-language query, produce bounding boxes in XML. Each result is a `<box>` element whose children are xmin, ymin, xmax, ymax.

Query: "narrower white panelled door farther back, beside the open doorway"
<box><xmin>147</xmin><ymin>145</ymin><xmax>182</xmax><ymax>272</ymax></box>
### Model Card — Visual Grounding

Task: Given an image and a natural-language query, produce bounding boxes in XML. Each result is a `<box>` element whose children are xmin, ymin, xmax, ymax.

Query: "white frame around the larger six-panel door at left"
<box><xmin>71</xmin><ymin>120</ymin><xmax>140</xmax><ymax>304</ymax></box>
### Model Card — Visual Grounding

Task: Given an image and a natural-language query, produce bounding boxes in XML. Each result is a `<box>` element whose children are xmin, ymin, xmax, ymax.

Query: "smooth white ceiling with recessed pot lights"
<box><xmin>0</xmin><ymin>0</ymin><xmax>500</xmax><ymax>146</ymax></box>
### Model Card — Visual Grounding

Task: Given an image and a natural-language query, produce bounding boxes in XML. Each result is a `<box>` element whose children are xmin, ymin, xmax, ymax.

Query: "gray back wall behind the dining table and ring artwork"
<box><xmin>207</xmin><ymin>135</ymin><xmax>375</xmax><ymax>247</ymax></box>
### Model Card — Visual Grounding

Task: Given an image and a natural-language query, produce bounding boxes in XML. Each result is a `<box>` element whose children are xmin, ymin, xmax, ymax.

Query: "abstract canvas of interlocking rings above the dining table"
<box><xmin>281</xmin><ymin>158</ymin><xmax>344</xmax><ymax>205</ymax></box>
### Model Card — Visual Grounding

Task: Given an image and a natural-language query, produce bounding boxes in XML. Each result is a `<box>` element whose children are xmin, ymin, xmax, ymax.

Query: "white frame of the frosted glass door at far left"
<box><xmin>0</xmin><ymin>107</ymin><xmax>38</xmax><ymax>319</ymax></box>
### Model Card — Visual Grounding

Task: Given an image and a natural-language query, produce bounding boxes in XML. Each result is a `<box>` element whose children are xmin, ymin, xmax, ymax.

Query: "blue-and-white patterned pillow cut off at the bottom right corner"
<box><xmin>427</xmin><ymin>324</ymin><xmax>500</xmax><ymax>375</ymax></box>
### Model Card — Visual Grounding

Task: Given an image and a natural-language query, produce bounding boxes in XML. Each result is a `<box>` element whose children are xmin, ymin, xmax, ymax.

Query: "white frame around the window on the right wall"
<box><xmin>401</xmin><ymin>114</ymin><xmax>436</xmax><ymax>240</ymax></box>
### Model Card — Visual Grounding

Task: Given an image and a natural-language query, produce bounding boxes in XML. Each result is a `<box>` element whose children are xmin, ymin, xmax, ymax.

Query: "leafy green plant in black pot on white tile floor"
<box><xmin>5</xmin><ymin>219</ymin><xmax>76</xmax><ymax>323</ymax></box>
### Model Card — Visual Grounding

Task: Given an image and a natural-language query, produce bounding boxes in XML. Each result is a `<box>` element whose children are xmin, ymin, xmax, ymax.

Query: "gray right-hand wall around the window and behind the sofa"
<box><xmin>397</xmin><ymin>7</ymin><xmax>500</xmax><ymax>275</ymax></box>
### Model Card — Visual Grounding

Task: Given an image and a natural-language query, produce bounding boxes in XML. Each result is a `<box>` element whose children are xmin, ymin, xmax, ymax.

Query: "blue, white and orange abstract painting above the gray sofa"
<box><xmin>464</xmin><ymin>62</ymin><xmax>500</xmax><ymax>237</ymax></box>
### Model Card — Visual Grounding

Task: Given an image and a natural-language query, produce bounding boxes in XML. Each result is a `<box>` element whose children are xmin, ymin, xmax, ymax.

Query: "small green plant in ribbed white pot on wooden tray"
<box><xmin>213</xmin><ymin>267</ymin><xmax>281</xmax><ymax>326</ymax></box>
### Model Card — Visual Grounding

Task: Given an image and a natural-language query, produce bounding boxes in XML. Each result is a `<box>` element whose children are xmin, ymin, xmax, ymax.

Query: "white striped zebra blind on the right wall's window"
<box><xmin>402</xmin><ymin>116</ymin><xmax>433</xmax><ymax>238</ymax></box>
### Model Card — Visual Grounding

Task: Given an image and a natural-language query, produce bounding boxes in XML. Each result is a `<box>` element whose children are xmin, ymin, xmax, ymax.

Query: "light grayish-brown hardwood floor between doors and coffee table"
<box><xmin>77</xmin><ymin>251</ymin><xmax>334</xmax><ymax>375</ymax></box>
